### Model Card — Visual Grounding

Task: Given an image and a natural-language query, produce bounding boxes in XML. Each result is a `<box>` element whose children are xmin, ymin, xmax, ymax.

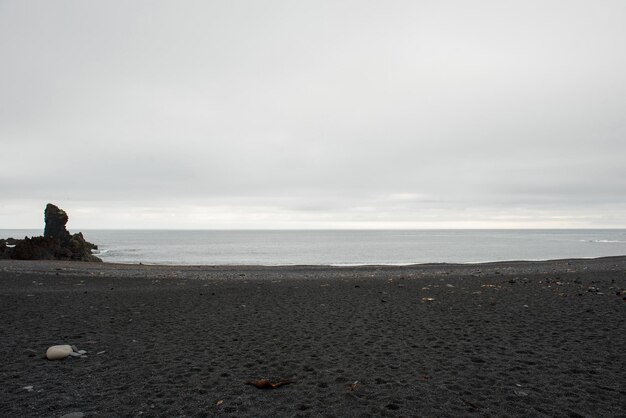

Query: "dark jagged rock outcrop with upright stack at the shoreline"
<box><xmin>0</xmin><ymin>203</ymin><xmax>102</xmax><ymax>262</ymax></box>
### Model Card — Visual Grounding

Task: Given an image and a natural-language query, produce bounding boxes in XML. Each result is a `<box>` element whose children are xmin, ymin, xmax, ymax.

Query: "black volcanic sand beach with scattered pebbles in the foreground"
<box><xmin>0</xmin><ymin>257</ymin><xmax>626</xmax><ymax>417</ymax></box>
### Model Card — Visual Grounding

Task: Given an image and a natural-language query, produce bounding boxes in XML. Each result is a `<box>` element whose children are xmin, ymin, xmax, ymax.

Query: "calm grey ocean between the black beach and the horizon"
<box><xmin>0</xmin><ymin>229</ymin><xmax>626</xmax><ymax>265</ymax></box>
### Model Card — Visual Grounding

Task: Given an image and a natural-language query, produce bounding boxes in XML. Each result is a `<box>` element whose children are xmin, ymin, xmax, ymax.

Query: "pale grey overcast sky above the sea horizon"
<box><xmin>0</xmin><ymin>0</ymin><xmax>626</xmax><ymax>229</ymax></box>
